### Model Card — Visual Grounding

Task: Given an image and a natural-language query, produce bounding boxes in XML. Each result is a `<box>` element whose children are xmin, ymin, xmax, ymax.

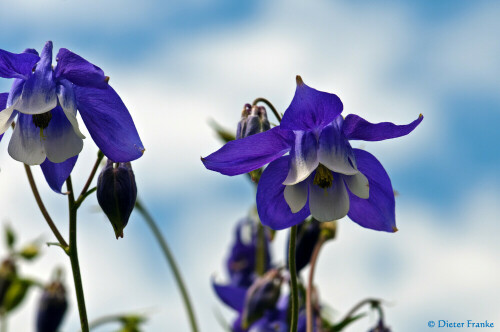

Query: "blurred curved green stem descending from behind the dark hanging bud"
<box><xmin>135</xmin><ymin>199</ymin><xmax>199</xmax><ymax>332</ymax></box>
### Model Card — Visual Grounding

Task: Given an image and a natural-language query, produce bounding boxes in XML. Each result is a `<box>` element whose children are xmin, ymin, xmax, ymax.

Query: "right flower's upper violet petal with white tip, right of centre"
<box><xmin>318</xmin><ymin>122</ymin><xmax>358</xmax><ymax>175</ymax></box>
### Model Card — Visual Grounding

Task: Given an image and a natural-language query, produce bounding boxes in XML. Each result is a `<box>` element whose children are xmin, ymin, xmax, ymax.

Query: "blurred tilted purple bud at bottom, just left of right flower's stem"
<box><xmin>241</xmin><ymin>269</ymin><xmax>283</xmax><ymax>329</ymax></box>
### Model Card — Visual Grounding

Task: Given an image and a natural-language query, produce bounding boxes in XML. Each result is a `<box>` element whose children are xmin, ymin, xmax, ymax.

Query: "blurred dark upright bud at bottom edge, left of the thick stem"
<box><xmin>36</xmin><ymin>281</ymin><xmax>68</xmax><ymax>332</ymax></box>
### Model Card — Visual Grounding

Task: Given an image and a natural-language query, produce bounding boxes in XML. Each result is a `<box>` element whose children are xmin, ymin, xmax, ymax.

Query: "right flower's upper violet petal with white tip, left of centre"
<box><xmin>283</xmin><ymin>131</ymin><xmax>319</xmax><ymax>185</ymax></box>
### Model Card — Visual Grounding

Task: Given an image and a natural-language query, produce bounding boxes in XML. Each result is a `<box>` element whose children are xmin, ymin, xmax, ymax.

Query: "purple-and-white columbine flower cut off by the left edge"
<box><xmin>0</xmin><ymin>41</ymin><xmax>144</xmax><ymax>192</ymax></box>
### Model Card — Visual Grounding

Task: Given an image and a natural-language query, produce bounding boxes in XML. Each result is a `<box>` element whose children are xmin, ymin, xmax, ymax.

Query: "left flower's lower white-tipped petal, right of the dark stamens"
<box><xmin>42</xmin><ymin>107</ymin><xmax>83</xmax><ymax>163</ymax></box>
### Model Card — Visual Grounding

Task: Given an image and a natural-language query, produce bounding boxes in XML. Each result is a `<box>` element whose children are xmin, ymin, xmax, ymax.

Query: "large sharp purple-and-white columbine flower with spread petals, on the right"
<box><xmin>202</xmin><ymin>76</ymin><xmax>423</xmax><ymax>232</ymax></box>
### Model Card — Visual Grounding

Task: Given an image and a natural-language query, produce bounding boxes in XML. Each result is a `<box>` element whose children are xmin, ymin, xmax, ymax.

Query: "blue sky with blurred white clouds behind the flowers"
<box><xmin>0</xmin><ymin>0</ymin><xmax>500</xmax><ymax>332</ymax></box>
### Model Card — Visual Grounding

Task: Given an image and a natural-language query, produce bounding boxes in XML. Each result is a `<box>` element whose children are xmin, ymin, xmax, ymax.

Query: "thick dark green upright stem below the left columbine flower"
<box><xmin>66</xmin><ymin>176</ymin><xmax>89</xmax><ymax>332</ymax></box>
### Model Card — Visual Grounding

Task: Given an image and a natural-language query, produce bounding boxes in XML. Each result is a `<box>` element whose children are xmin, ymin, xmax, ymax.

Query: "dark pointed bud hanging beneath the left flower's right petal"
<box><xmin>97</xmin><ymin>159</ymin><xmax>137</xmax><ymax>239</ymax></box>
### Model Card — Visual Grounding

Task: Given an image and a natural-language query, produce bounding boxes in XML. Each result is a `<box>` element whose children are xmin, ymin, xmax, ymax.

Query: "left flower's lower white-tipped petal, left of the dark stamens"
<box><xmin>8</xmin><ymin>114</ymin><xmax>46</xmax><ymax>165</ymax></box>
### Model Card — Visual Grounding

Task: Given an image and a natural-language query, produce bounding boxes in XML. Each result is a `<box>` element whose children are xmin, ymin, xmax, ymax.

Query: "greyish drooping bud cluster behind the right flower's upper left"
<box><xmin>236</xmin><ymin>104</ymin><xmax>271</xmax><ymax>139</ymax></box>
